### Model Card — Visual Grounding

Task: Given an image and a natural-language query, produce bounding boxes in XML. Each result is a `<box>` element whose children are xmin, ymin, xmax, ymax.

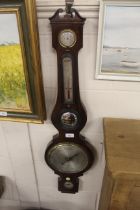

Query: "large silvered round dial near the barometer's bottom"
<box><xmin>47</xmin><ymin>142</ymin><xmax>88</xmax><ymax>173</ymax></box>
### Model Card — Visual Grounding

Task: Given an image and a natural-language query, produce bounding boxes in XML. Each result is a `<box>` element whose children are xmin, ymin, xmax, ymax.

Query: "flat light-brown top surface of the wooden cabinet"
<box><xmin>104</xmin><ymin>118</ymin><xmax>140</xmax><ymax>174</ymax></box>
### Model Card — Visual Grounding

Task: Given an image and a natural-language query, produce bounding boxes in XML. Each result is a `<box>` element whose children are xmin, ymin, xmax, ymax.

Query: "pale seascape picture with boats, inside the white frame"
<box><xmin>101</xmin><ymin>5</ymin><xmax>140</xmax><ymax>74</ymax></box>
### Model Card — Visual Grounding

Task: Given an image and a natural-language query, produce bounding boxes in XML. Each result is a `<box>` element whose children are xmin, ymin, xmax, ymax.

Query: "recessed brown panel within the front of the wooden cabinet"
<box><xmin>109</xmin><ymin>174</ymin><xmax>140</xmax><ymax>210</ymax></box>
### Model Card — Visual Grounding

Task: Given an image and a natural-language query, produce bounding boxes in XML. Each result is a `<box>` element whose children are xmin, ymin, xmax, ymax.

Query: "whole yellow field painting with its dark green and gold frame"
<box><xmin>0</xmin><ymin>0</ymin><xmax>46</xmax><ymax>123</ymax></box>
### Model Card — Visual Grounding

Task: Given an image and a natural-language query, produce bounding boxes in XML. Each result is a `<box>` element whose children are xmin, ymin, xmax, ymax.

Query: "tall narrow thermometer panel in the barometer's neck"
<box><xmin>63</xmin><ymin>56</ymin><xmax>73</xmax><ymax>103</ymax></box>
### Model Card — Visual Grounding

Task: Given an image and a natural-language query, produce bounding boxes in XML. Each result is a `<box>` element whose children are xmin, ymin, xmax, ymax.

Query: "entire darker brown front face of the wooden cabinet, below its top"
<box><xmin>99</xmin><ymin>170</ymin><xmax>140</xmax><ymax>210</ymax></box>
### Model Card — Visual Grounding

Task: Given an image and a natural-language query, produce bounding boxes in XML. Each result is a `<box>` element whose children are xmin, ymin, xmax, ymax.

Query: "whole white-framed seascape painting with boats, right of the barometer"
<box><xmin>96</xmin><ymin>0</ymin><xmax>140</xmax><ymax>81</ymax></box>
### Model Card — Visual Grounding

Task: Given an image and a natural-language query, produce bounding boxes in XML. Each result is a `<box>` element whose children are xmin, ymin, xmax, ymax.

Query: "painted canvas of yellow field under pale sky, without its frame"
<box><xmin>0</xmin><ymin>12</ymin><xmax>30</xmax><ymax>112</ymax></box>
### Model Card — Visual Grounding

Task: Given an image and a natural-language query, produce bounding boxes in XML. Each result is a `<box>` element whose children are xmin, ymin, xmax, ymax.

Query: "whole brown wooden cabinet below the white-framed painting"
<box><xmin>99</xmin><ymin>118</ymin><xmax>140</xmax><ymax>210</ymax></box>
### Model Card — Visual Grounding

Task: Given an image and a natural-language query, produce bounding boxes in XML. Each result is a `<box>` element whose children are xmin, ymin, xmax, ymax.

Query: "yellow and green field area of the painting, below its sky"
<box><xmin>0</xmin><ymin>44</ymin><xmax>29</xmax><ymax>110</ymax></box>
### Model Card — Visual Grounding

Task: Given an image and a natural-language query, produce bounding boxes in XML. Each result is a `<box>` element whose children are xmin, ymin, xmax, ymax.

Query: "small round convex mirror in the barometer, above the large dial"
<box><xmin>61</xmin><ymin>112</ymin><xmax>78</xmax><ymax>127</ymax></box>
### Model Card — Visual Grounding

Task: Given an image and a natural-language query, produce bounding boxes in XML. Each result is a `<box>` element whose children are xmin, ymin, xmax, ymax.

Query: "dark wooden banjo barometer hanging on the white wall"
<box><xmin>45</xmin><ymin>0</ymin><xmax>95</xmax><ymax>193</ymax></box>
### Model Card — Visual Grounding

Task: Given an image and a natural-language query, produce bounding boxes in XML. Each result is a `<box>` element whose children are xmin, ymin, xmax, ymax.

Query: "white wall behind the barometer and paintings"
<box><xmin>0</xmin><ymin>0</ymin><xmax>140</xmax><ymax>210</ymax></box>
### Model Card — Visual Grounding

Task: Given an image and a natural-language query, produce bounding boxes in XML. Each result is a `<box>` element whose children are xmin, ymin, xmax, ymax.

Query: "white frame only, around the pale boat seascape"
<box><xmin>95</xmin><ymin>0</ymin><xmax>140</xmax><ymax>81</ymax></box>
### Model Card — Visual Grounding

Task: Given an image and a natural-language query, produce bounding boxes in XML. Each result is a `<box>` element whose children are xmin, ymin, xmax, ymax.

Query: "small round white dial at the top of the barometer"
<box><xmin>58</xmin><ymin>29</ymin><xmax>76</xmax><ymax>47</ymax></box>
